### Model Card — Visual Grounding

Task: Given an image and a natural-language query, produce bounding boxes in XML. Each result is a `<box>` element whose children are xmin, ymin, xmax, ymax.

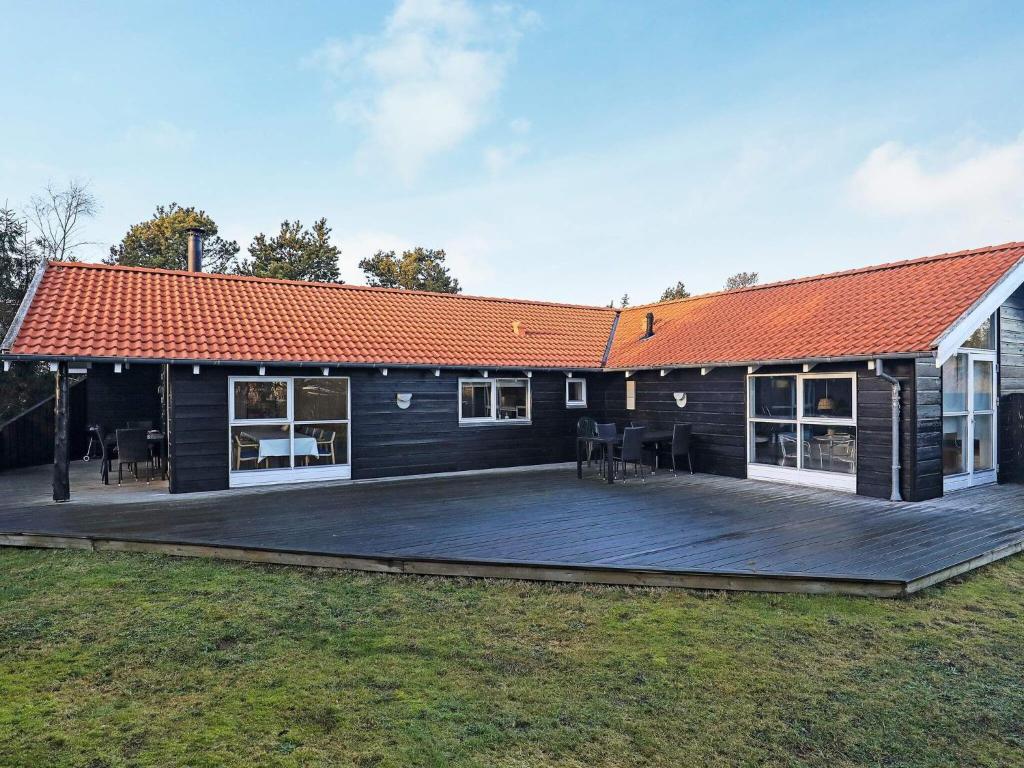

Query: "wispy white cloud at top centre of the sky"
<box><xmin>304</xmin><ymin>0</ymin><xmax>536</xmax><ymax>183</ymax></box>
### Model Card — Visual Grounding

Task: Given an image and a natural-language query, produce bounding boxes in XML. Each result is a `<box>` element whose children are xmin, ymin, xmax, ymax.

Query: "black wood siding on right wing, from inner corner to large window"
<box><xmin>599</xmin><ymin>368</ymin><xmax>746</xmax><ymax>477</ymax></box>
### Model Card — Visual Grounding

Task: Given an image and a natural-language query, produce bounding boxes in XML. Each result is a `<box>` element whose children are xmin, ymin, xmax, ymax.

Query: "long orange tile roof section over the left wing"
<box><xmin>4</xmin><ymin>262</ymin><xmax>615</xmax><ymax>368</ymax></box>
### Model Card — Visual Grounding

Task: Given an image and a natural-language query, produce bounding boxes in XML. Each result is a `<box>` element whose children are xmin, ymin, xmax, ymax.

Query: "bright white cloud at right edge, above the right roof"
<box><xmin>851</xmin><ymin>135</ymin><xmax>1024</xmax><ymax>218</ymax></box>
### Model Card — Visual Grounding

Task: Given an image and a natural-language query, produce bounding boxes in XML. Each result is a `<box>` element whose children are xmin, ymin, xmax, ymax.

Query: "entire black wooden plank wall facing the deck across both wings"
<box><xmin>161</xmin><ymin>360</ymin><xmax>929</xmax><ymax>499</ymax></box>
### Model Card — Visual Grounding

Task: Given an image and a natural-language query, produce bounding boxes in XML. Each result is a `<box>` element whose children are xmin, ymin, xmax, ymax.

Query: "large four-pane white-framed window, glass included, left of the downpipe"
<box><xmin>746</xmin><ymin>373</ymin><xmax>857</xmax><ymax>490</ymax></box>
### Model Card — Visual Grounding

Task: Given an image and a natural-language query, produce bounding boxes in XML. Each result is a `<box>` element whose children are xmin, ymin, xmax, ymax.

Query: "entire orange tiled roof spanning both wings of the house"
<box><xmin>10</xmin><ymin>243</ymin><xmax>1024</xmax><ymax>369</ymax></box>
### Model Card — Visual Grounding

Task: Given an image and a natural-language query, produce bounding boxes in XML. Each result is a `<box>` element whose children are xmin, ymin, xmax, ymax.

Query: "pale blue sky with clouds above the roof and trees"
<box><xmin>0</xmin><ymin>0</ymin><xmax>1024</xmax><ymax>303</ymax></box>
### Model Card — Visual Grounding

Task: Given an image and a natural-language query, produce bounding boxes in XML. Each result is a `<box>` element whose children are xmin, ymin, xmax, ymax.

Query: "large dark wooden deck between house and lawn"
<box><xmin>0</xmin><ymin>464</ymin><xmax>1024</xmax><ymax>596</ymax></box>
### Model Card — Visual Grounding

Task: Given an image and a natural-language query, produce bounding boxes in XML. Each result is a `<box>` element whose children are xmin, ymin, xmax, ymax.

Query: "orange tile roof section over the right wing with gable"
<box><xmin>607</xmin><ymin>243</ymin><xmax>1024</xmax><ymax>369</ymax></box>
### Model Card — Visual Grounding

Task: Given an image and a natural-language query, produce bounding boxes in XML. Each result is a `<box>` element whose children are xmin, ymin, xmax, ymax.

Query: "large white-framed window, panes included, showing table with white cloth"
<box><xmin>227</xmin><ymin>376</ymin><xmax>351</xmax><ymax>487</ymax></box>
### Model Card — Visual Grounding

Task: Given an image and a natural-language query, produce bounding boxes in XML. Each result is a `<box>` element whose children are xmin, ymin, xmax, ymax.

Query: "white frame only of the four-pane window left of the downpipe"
<box><xmin>744</xmin><ymin>372</ymin><xmax>860</xmax><ymax>493</ymax></box>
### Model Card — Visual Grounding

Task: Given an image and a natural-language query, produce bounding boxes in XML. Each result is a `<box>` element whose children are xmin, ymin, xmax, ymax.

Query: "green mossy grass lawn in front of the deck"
<box><xmin>0</xmin><ymin>549</ymin><xmax>1024</xmax><ymax>768</ymax></box>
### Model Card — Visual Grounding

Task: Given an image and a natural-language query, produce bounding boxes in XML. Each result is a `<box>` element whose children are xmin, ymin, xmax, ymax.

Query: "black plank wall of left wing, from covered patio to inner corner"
<box><xmin>162</xmin><ymin>366</ymin><xmax>601</xmax><ymax>493</ymax></box>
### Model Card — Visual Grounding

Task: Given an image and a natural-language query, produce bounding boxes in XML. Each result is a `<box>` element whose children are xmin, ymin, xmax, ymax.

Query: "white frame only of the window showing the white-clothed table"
<box><xmin>227</xmin><ymin>374</ymin><xmax>352</xmax><ymax>488</ymax></box>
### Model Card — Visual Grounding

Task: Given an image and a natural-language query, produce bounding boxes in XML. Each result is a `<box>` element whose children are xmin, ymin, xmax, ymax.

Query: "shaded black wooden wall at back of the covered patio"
<box><xmin>86</xmin><ymin>362</ymin><xmax>163</xmax><ymax>432</ymax></box>
